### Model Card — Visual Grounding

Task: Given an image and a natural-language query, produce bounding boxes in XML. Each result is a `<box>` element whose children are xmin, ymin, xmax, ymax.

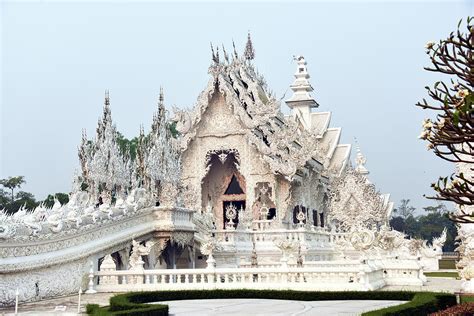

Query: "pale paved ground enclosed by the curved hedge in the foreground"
<box><xmin>153</xmin><ymin>299</ymin><xmax>404</xmax><ymax>316</ymax></box>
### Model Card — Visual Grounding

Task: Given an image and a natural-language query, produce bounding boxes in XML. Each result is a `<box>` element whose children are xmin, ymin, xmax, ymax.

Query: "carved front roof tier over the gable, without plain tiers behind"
<box><xmin>173</xmin><ymin>37</ymin><xmax>350</xmax><ymax>180</ymax></box>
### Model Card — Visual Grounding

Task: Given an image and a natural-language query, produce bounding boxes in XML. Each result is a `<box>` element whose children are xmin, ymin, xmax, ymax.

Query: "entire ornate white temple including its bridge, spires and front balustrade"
<box><xmin>0</xmin><ymin>36</ymin><xmax>445</xmax><ymax>304</ymax></box>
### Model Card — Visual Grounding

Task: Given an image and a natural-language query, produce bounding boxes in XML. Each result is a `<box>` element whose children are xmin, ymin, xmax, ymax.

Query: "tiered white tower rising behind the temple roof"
<box><xmin>285</xmin><ymin>56</ymin><xmax>319</xmax><ymax>128</ymax></box>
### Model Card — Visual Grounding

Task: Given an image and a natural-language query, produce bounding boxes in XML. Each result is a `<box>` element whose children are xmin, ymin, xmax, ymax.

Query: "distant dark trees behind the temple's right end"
<box><xmin>390</xmin><ymin>199</ymin><xmax>457</xmax><ymax>252</ymax></box>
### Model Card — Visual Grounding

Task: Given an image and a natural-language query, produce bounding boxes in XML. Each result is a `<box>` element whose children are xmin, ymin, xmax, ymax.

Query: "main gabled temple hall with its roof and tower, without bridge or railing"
<box><xmin>174</xmin><ymin>38</ymin><xmax>351</xmax><ymax>229</ymax></box>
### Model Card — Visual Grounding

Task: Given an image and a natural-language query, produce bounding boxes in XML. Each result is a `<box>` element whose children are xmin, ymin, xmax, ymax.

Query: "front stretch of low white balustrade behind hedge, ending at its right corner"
<box><xmin>95</xmin><ymin>265</ymin><xmax>385</xmax><ymax>292</ymax></box>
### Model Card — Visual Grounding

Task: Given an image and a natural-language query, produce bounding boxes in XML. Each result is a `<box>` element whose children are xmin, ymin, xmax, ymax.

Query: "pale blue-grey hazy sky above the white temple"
<box><xmin>0</xmin><ymin>0</ymin><xmax>474</xmax><ymax>212</ymax></box>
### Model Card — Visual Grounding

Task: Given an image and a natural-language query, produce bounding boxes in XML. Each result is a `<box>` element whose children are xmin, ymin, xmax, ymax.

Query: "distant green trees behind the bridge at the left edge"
<box><xmin>0</xmin><ymin>176</ymin><xmax>69</xmax><ymax>214</ymax></box>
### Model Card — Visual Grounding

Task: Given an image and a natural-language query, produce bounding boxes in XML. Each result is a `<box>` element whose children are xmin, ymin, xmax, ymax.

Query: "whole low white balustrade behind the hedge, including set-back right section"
<box><xmin>89</xmin><ymin>260</ymin><xmax>424</xmax><ymax>292</ymax></box>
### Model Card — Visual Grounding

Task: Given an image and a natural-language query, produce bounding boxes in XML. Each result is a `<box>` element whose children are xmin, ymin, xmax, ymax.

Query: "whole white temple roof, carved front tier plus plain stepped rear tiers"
<box><xmin>174</xmin><ymin>41</ymin><xmax>350</xmax><ymax>180</ymax></box>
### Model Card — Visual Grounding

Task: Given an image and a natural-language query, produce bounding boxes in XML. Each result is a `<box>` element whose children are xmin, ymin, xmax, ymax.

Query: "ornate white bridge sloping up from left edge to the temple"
<box><xmin>0</xmin><ymin>207</ymin><xmax>194</xmax><ymax>305</ymax></box>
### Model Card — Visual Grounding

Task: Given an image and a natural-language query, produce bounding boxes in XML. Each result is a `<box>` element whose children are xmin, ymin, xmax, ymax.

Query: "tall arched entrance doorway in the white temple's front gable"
<box><xmin>201</xmin><ymin>149</ymin><xmax>246</xmax><ymax>229</ymax></box>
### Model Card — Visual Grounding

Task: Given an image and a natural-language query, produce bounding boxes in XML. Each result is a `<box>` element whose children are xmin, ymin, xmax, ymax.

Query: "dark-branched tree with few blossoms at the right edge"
<box><xmin>416</xmin><ymin>17</ymin><xmax>474</xmax><ymax>223</ymax></box>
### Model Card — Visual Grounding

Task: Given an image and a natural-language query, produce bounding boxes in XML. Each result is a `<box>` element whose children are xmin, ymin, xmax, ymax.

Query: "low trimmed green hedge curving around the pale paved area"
<box><xmin>87</xmin><ymin>289</ymin><xmax>456</xmax><ymax>316</ymax></box>
